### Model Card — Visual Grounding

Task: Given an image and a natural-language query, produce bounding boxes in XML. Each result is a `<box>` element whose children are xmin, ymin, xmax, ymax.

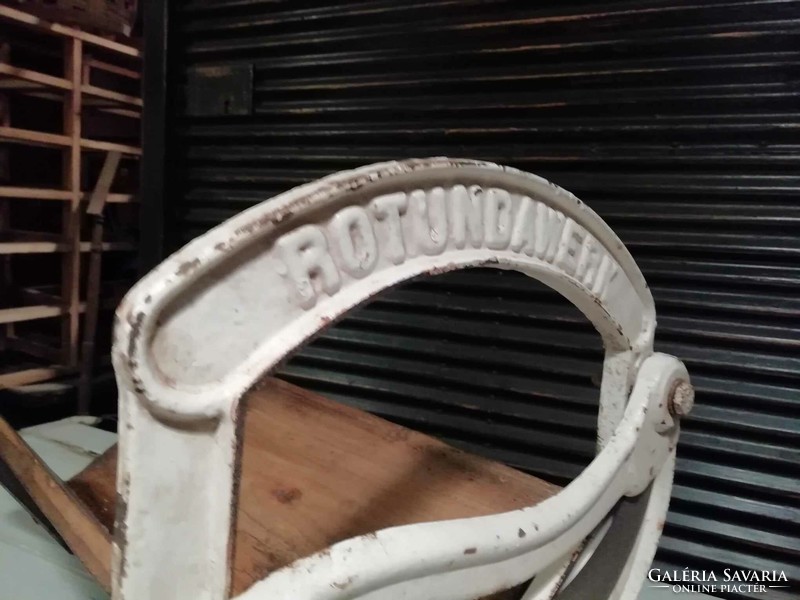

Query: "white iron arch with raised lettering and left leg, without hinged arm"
<box><xmin>109</xmin><ymin>158</ymin><xmax>680</xmax><ymax>600</ymax></box>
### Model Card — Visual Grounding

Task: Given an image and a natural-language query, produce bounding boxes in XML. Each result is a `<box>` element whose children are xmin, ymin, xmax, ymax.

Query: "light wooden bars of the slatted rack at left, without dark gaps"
<box><xmin>0</xmin><ymin>6</ymin><xmax>142</xmax><ymax>396</ymax></box>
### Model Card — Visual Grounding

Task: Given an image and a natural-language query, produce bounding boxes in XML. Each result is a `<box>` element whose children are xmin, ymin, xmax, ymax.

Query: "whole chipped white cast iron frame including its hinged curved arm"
<box><xmin>113</xmin><ymin>158</ymin><xmax>688</xmax><ymax>600</ymax></box>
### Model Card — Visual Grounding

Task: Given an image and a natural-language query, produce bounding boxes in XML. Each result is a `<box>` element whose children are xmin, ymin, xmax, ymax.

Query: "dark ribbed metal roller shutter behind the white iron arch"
<box><xmin>150</xmin><ymin>0</ymin><xmax>800</xmax><ymax>598</ymax></box>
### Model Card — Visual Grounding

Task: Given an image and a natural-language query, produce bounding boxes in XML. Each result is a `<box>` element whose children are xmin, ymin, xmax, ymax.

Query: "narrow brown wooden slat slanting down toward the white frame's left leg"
<box><xmin>0</xmin><ymin>418</ymin><xmax>111</xmax><ymax>589</ymax></box>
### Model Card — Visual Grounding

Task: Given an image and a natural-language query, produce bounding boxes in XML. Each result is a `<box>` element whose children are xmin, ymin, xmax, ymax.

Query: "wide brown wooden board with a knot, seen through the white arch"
<box><xmin>69</xmin><ymin>378</ymin><xmax>559</xmax><ymax>598</ymax></box>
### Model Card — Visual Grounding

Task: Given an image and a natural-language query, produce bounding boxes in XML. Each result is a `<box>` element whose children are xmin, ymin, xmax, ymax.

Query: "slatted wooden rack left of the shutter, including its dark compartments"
<box><xmin>0</xmin><ymin>6</ymin><xmax>142</xmax><ymax>398</ymax></box>
